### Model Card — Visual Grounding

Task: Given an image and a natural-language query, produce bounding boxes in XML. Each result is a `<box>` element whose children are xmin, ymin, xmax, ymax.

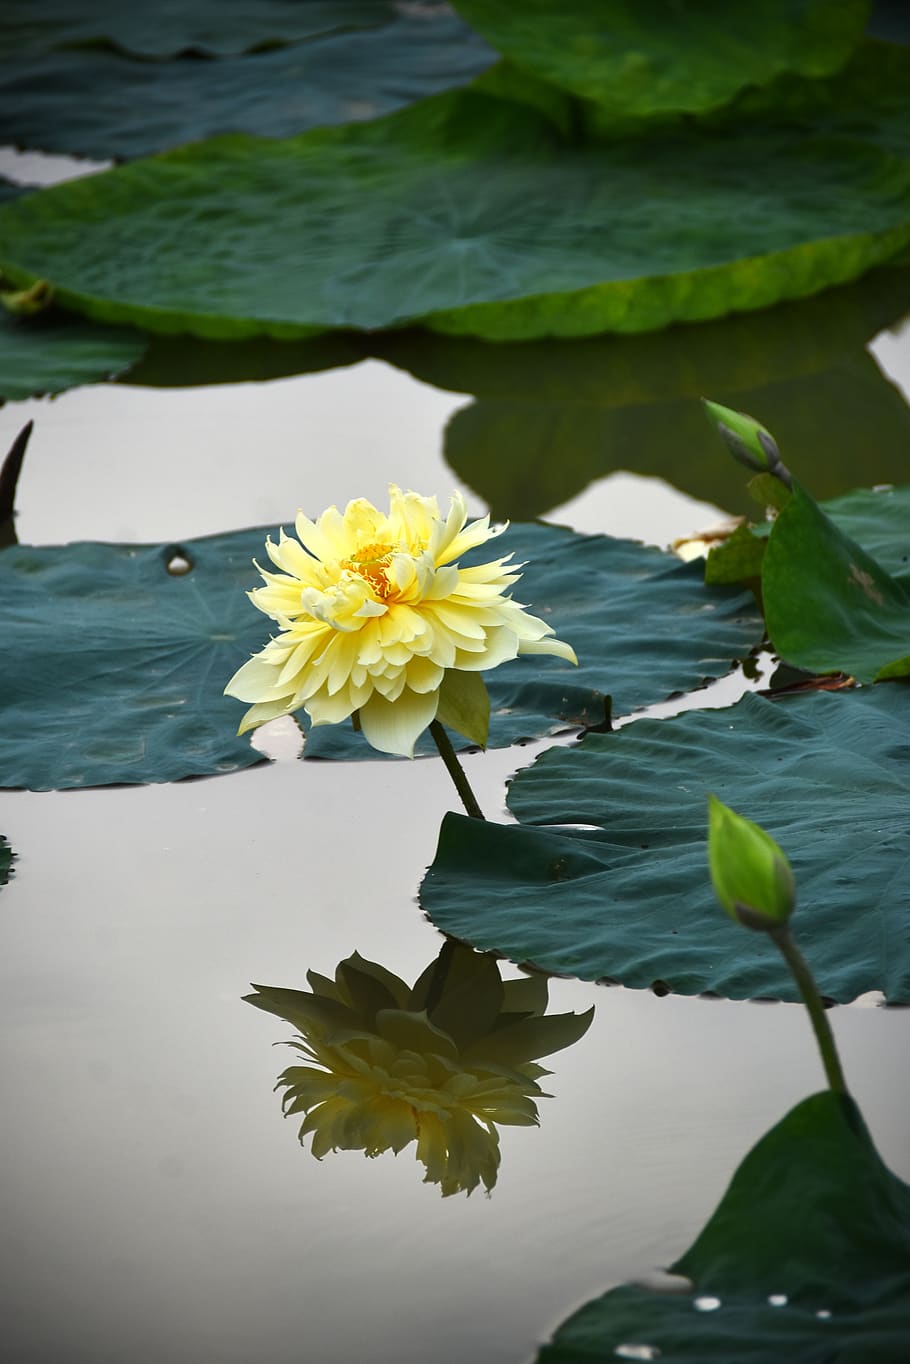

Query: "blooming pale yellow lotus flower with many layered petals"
<box><xmin>225</xmin><ymin>484</ymin><xmax>577</xmax><ymax>757</ymax></box>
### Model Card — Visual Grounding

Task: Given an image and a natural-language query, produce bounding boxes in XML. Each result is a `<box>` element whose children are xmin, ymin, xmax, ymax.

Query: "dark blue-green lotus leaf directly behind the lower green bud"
<box><xmin>422</xmin><ymin>683</ymin><xmax>910</xmax><ymax>1003</ymax></box>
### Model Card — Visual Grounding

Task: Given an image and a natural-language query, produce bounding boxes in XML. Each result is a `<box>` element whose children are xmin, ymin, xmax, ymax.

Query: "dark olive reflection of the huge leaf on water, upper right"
<box><xmin>372</xmin><ymin>269</ymin><xmax>910</xmax><ymax>515</ymax></box>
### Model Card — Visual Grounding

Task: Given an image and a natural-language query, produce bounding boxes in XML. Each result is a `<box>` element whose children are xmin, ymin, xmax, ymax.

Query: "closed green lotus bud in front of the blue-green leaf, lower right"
<box><xmin>708</xmin><ymin>795</ymin><xmax>797</xmax><ymax>933</ymax></box>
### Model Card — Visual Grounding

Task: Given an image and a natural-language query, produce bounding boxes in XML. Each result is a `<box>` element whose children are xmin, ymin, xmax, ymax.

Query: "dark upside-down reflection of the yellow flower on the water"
<box><xmin>246</xmin><ymin>943</ymin><xmax>593</xmax><ymax>1198</ymax></box>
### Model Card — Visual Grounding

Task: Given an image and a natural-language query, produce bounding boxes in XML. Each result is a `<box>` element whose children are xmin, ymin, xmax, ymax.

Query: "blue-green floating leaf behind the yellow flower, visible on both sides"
<box><xmin>0</xmin><ymin>525</ymin><xmax>761</xmax><ymax>790</ymax></box>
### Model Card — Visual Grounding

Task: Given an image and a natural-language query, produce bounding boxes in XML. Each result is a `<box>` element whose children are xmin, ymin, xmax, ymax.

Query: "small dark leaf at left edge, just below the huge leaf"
<box><xmin>0</xmin><ymin>310</ymin><xmax>147</xmax><ymax>402</ymax></box>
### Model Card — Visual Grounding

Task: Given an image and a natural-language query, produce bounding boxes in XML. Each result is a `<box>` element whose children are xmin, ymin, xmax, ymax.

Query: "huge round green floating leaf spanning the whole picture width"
<box><xmin>0</xmin><ymin>69</ymin><xmax>910</xmax><ymax>340</ymax></box>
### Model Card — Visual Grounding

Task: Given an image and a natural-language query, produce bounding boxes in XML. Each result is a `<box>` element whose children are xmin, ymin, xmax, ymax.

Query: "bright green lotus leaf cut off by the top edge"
<box><xmin>454</xmin><ymin>0</ymin><xmax>868</xmax><ymax>117</ymax></box>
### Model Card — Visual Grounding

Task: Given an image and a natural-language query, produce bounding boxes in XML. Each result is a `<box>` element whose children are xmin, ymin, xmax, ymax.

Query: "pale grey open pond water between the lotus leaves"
<box><xmin>0</xmin><ymin>215</ymin><xmax>910</xmax><ymax>1364</ymax></box>
